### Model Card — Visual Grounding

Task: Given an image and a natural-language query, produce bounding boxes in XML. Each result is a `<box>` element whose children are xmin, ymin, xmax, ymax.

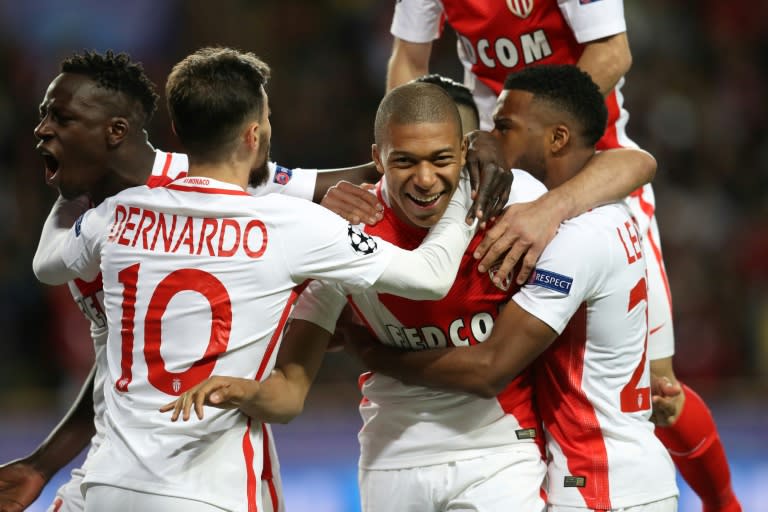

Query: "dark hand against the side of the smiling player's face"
<box><xmin>466</xmin><ymin>130</ymin><xmax>513</xmax><ymax>228</ymax></box>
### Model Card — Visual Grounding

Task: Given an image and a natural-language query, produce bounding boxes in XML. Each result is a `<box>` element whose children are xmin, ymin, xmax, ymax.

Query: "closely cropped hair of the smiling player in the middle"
<box><xmin>374</xmin><ymin>82</ymin><xmax>463</xmax><ymax>144</ymax></box>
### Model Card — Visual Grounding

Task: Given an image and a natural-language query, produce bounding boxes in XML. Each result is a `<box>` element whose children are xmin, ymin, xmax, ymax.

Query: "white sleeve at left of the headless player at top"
<box><xmin>390</xmin><ymin>0</ymin><xmax>443</xmax><ymax>43</ymax></box>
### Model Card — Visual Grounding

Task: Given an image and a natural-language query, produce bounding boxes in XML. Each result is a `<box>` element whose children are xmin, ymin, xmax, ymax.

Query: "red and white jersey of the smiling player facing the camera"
<box><xmin>294</xmin><ymin>170</ymin><xmax>546</xmax><ymax>469</ymax></box>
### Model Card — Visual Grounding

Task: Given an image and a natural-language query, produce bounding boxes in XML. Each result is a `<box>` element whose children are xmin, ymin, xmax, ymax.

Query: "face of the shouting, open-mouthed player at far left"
<box><xmin>34</xmin><ymin>73</ymin><xmax>114</xmax><ymax>198</ymax></box>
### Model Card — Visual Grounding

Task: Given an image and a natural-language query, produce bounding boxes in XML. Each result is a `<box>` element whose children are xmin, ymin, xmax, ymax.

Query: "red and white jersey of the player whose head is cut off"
<box><xmin>391</xmin><ymin>0</ymin><xmax>635</xmax><ymax>149</ymax></box>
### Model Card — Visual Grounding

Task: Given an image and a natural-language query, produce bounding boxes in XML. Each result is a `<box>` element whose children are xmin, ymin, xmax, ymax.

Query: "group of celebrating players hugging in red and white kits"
<box><xmin>0</xmin><ymin>0</ymin><xmax>741</xmax><ymax>512</ymax></box>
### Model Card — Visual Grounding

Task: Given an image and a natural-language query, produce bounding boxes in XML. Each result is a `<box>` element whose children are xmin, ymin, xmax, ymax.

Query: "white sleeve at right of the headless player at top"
<box><xmin>557</xmin><ymin>0</ymin><xmax>627</xmax><ymax>43</ymax></box>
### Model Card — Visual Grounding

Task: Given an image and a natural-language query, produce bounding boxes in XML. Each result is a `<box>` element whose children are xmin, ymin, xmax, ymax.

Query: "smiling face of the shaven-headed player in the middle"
<box><xmin>373</xmin><ymin>121</ymin><xmax>466</xmax><ymax>228</ymax></box>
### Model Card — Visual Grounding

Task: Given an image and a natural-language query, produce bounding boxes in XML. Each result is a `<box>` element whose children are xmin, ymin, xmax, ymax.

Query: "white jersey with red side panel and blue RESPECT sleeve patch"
<box><xmin>512</xmin><ymin>204</ymin><xmax>678</xmax><ymax>510</ymax></box>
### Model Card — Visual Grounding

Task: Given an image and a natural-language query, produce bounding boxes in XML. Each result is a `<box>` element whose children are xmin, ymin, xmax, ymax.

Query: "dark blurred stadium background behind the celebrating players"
<box><xmin>0</xmin><ymin>0</ymin><xmax>768</xmax><ymax>512</ymax></box>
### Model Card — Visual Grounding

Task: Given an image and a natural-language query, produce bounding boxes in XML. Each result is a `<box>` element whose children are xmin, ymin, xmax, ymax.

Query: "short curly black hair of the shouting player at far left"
<box><xmin>60</xmin><ymin>50</ymin><xmax>159</xmax><ymax>124</ymax></box>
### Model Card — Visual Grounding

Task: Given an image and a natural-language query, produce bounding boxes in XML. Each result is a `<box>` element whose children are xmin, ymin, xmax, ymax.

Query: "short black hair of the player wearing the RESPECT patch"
<box><xmin>504</xmin><ymin>64</ymin><xmax>608</xmax><ymax>146</ymax></box>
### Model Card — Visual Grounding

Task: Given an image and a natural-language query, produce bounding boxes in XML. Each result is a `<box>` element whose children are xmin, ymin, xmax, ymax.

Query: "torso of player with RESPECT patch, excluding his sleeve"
<box><xmin>534</xmin><ymin>206</ymin><xmax>676</xmax><ymax>509</ymax></box>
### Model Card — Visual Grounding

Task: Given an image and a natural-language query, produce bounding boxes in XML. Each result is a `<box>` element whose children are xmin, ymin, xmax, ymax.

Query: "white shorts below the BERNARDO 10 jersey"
<box><xmin>85</xmin><ymin>484</ymin><xmax>225</xmax><ymax>512</ymax></box>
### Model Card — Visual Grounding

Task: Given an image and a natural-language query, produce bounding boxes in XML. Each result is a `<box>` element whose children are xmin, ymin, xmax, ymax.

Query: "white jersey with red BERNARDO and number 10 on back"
<box><xmin>55</xmin><ymin>177</ymin><xmax>399</xmax><ymax>511</ymax></box>
